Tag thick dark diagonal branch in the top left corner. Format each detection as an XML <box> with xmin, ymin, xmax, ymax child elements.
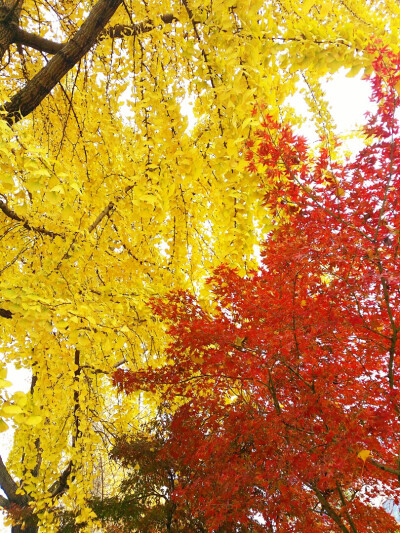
<box><xmin>2</xmin><ymin>0</ymin><xmax>122</xmax><ymax>125</ymax></box>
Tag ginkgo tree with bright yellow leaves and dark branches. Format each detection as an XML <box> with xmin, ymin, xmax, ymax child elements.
<box><xmin>0</xmin><ymin>0</ymin><xmax>400</xmax><ymax>532</ymax></box>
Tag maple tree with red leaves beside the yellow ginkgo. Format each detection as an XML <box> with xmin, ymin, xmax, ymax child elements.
<box><xmin>115</xmin><ymin>50</ymin><xmax>400</xmax><ymax>533</ymax></box>
